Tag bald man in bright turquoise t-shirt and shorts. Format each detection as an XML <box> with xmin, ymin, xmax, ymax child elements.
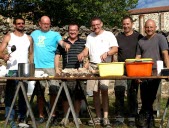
<box><xmin>31</xmin><ymin>16</ymin><xmax>70</xmax><ymax>125</ymax></box>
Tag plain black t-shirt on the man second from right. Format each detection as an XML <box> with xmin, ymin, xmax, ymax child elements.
<box><xmin>116</xmin><ymin>31</ymin><xmax>143</xmax><ymax>62</ymax></box>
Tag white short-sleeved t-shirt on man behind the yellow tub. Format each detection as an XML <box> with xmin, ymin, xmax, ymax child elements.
<box><xmin>86</xmin><ymin>30</ymin><xmax>118</xmax><ymax>63</ymax></box>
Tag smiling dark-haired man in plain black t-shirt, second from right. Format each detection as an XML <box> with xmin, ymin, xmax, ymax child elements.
<box><xmin>114</xmin><ymin>16</ymin><xmax>143</xmax><ymax>127</ymax></box>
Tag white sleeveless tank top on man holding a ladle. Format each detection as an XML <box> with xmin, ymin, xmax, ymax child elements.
<box><xmin>7</xmin><ymin>33</ymin><xmax>30</xmax><ymax>70</ymax></box>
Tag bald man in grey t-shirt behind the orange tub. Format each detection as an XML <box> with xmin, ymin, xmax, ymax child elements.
<box><xmin>136</xmin><ymin>19</ymin><xmax>169</xmax><ymax>128</ymax></box>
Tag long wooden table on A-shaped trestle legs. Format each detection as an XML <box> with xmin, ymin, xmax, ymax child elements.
<box><xmin>0</xmin><ymin>76</ymin><xmax>169</xmax><ymax>128</ymax></box>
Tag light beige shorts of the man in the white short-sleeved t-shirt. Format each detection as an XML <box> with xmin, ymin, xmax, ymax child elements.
<box><xmin>87</xmin><ymin>63</ymin><xmax>110</xmax><ymax>92</ymax></box>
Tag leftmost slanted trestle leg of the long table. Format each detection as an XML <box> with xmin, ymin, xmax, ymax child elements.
<box><xmin>4</xmin><ymin>84</ymin><xmax>21</xmax><ymax>128</ymax></box>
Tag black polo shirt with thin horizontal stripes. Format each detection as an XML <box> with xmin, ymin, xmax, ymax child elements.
<box><xmin>56</xmin><ymin>38</ymin><xmax>86</xmax><ymax>69</ymax></box>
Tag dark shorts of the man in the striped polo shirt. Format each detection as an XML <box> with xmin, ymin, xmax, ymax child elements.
<box><xmin>61</xmin><ymin>80</ymin><xmax>84</xmax><ymax>101</ymax></box>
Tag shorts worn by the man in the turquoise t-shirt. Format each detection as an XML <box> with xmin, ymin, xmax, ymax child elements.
<box><xmin>35</xmin><ymin>68</ymin><xmax>60</xmax><ymax>96</ymax></box>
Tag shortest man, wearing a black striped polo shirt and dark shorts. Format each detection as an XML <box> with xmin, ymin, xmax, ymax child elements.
<box><xmin>55</xmin><ymin>23</ymin><xmax>86</xmax><ymax>125</ymax></box>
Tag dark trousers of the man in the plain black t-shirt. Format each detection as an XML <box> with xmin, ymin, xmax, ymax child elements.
<box><xmin>114</xmin><ymin>80</ymin><xmax>138</xmax><ymax>117</ymax></box>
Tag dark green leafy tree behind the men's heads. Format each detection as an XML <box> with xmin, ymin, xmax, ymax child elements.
<box><xmin>0</xmin><ymin>0</ymin><xmax>138</xmax><ymax>26</ymax></box>
